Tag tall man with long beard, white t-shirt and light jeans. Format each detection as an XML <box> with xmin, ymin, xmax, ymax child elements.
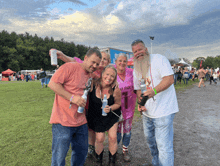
<box><xmin>131</xmin><ymin>39</ymin><xmax>179</xmax><ymax>166</ymax></box>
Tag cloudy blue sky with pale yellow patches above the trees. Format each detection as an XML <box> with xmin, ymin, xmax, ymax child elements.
<box><xmin>0</xmin><ymin>0</ymin><xmax>220</xmax><ymax>62</ymax></box>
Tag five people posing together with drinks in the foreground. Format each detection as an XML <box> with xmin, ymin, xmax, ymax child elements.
<box><xmin>48</xmin><ymin>39</ymin><xmax>179</xmax><ymax>166</ymax></box>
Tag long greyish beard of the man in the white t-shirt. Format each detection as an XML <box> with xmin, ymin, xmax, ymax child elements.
<box><xmin>134</xmin><ymin>51</ymin><xmax>150</xmax><ymax>80</ymax></box>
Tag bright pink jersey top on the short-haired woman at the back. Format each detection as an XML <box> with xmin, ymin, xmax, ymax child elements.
<box><xmin>117</xmin><ymin>68</ymin><xmax>136</xmax><ymax>119</ymax></box>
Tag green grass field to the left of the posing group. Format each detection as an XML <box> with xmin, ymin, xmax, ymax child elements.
<box><xmin>0</xmin><ymin>81</ymin><xmax>199</xmax><ymax>166</ymax></box>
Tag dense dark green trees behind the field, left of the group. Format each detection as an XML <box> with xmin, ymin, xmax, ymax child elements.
<box><xmin>0</xmin><ymin>30</ymin><xmax>90</xmax><ymax>73</ymax></box>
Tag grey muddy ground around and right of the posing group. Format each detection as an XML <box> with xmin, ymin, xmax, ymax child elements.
<box><xmin>85</xmin><ymin>82</ymin><xmax>220</xmax><ymax>166</ymax></box>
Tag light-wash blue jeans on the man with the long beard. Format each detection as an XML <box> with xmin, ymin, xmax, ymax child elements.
<box><xmin>143</xmin><ymin>114</ymin><xmax>175</xmax><ymax>166</ymax></box>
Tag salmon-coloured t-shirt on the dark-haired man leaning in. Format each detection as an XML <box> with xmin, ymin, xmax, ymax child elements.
<box><xmin>50</xmin><ymin>62</ymin><xmax>90</xmax><ymax>127</ymax></box>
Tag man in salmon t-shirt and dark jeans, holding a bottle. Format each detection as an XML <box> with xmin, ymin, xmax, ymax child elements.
<box><xmin>48</xmin><ymin>49</ymin><xmax>102</xmax><ymax>166</ymax></box>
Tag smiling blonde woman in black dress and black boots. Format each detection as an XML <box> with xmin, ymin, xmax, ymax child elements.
<box><xmin>86</xmin><ymin>65</ymin><xmax>121</xmax><ymax>165</ymax></box>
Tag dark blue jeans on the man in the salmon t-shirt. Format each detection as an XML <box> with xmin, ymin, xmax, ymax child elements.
<box><xmin>51</xmin><ymin>124</ymin><xmax>88</xmax><ymax>166</ymax></box>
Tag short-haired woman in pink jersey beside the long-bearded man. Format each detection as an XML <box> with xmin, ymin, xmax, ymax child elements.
<box><xmin>115</xmin><ymin>53</ymin><xmax>136</xmax><ymax>162</ymax></box>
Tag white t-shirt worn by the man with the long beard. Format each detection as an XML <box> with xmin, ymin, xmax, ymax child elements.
<box><xmin>133</xmin><ymin>54</ymin><xmax>179</xmax><ymax>118</ymax></box>
